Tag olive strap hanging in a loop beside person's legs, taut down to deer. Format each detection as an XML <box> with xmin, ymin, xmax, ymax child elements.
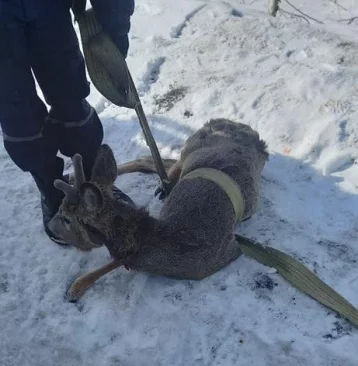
<box><xmin>72</xmin><ymin>5</ymin><xmax>172</xmax><ymax>195</ymax></box>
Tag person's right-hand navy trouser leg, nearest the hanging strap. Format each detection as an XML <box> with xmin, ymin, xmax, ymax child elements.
<box><xmin>28</xmin><ymin>0</ymin><xmax>103</xmax><ymax>178</ymax></box>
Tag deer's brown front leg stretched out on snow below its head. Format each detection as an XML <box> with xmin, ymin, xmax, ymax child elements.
<box><xmin>67</xmin><ymin>259</ymin><xmax>124</xmax><ymax>302</ymax></box>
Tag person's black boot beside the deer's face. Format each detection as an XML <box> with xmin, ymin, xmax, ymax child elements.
<box><xmin>31</xmin><ymin>157</ymin><xmax>68</xmax><ymax>245</ymax></box>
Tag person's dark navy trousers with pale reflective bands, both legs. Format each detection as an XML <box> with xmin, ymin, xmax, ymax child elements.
<box><xmin>0</xmin><ymin>0</ymin><xmax>103</xmax><ymax>179</ymax></box>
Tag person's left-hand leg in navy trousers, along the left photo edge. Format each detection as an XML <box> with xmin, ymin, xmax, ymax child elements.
<box><xmin>0</xmin><ymin>3</ymin><xmax>63</xmax><ymax>242</ymax></box>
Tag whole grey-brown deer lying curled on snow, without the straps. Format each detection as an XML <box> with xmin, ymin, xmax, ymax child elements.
<box><xmin>50</xmin><ymin>119</ymin><xmax>268</xmax><ymax>300</ymax></box>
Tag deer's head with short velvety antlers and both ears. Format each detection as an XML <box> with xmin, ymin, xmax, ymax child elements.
<box><xmin>49</xmin><ymin>145</ymin><xmax>121</xmax><ymax>250</ymax></box>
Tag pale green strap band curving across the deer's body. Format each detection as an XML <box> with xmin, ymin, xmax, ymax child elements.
<box><xmin>180</xmin><ymin>168</ymin><xmax>245</xmax><ymax>221</ymax></box>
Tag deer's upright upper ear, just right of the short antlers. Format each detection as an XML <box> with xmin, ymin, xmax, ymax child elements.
<box><xmin>91</xmin><ymin>145</ymin><xmax>117</xmax><ymax>188</ymax></box>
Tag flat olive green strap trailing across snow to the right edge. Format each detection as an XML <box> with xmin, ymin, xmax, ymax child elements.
<box><xmin>236</xmin><ymin>235</ymin><xmax>358</xmax><ymax>327</ymax></box>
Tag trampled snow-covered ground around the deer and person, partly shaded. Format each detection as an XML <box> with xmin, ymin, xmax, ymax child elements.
<box><xmin>0</xmin><ymin>0</ymin><xmax>358</xmax><ymax>366</ymax></box>
